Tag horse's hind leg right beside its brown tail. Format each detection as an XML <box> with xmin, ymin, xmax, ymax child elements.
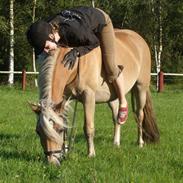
<box><xmin>132</xmin><ymin>83</ymin><xmax>148</xmax><ymax>147</ymax></box>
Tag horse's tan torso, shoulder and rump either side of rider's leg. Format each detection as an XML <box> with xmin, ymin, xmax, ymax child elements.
<box><xmin>76</xmin><ymin>30</ymin><xmax>151</xmax><ymax>100</ymax></box>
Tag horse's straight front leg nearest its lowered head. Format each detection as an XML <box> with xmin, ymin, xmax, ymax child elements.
<box><xmin>83</xmin><ymin>89</ymin><xmax>95</xmax><ymax>157</ymax></box>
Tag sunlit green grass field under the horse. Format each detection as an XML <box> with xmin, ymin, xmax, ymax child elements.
<box><xmin>0</xmin><ymin>86</ymin><xmax>183</xmax><ymax>183</ymax></box>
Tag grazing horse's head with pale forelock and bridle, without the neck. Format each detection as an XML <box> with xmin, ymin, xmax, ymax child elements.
<box><xmin>30</xmin><ymin>100</ymin><xmax>69</xmax><ymax>165</ymax></box>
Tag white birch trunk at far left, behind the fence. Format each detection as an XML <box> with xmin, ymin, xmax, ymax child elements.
<box><xmin>8</xmin><ymin>0</ymin><xmax>14</xmax><ymax>85</ymax></box>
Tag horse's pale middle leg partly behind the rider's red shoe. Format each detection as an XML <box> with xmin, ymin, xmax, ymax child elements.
<box><xmin>109</xmin><ymin>99</ymin><xmax>121</xmax><ymax>146</ymax></box>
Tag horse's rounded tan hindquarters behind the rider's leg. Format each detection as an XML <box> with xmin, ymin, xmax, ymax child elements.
<box><xmin>115</xmin><ymin>29</ymin><xmax>151</xmax><ymax>88</ymax></box>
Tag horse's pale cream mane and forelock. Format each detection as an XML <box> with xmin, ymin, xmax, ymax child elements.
<box><xmin>38</xmin><ymin>49</ymin><xmax>70</xmax><ymax>144</ymax></box>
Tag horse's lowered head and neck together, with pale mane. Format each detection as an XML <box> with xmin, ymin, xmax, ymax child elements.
<box><xmin>31</xmin><ymin>48</ymin><xmax>77</xmax><ymax>165</ymax></box>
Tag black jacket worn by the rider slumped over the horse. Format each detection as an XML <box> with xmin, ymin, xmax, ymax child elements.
<box><xmin>48</xmin><ymin>7</ymin><xmax>106</xmax><ymax>56</ymax></box>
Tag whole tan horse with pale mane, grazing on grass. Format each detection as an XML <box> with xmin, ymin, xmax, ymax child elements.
<box><xmin>30</xmin><ymin>30</ymin><xmax>159</xmax><ymax>164</ymax></box>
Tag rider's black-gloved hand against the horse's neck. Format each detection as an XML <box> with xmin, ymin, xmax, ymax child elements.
<box><xmin>62</xmin><ymin>49</ymin><xmax>79</xmax><ymax>69</ymax></box>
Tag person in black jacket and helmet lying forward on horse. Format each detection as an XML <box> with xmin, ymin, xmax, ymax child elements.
<box><xmin>27</xmin><ymin>7</ymin><xmax>128</xmax><ymax>124</ymax></box>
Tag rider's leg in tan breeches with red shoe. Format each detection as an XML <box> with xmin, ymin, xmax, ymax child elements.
<box><xmin>100</xmin><ymin>10</ymin><xmax>128</xmax><ymax>124</ymax></box>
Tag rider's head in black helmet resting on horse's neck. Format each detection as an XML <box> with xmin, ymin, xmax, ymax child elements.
<box><xmin>27</xmin><ymin>20</ymin><xmax>60</xmax><ymax>55</ymax></box>
